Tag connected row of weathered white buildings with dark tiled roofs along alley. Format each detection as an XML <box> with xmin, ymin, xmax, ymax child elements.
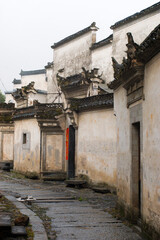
<box><xmin>3</xmin><ymin>3</ymin><xmax>160</xmax><ymax>234</ymax></box>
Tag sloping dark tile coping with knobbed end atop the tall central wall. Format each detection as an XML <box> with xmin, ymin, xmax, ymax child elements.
<box><xmin>51</xmin><ymin>22</ymin><xmax>98</xmax><ymax>49</ymax></box>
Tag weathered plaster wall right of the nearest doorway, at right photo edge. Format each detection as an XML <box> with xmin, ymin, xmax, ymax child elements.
<box><xmin>143</xmin><ymin>53</ymin><xmax>160</xmax><ymax>232</ymax></box>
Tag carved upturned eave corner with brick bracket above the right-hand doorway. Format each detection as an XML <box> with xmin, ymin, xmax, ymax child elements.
<box><xmin>108</xmin><ymin>33</ymin><xmax>144</xmax><ymax>107</ymax></box>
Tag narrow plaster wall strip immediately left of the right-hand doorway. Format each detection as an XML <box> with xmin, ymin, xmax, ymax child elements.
<box><xmin>114</xmin><ymin>87</ymin><xmax>131</xmax><ymax>204</ymax></box>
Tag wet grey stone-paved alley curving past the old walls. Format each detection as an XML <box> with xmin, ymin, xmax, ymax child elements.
<box><xmin>0</xmin><ymin>172</ymin><xmax>146</xmax><ymax>240</ymax></box>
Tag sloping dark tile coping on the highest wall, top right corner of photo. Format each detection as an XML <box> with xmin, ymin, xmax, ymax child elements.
<box><xmin>110</xmin><ymin>2</ymin><xmax>160</xmax><ymax>29</ymax></box>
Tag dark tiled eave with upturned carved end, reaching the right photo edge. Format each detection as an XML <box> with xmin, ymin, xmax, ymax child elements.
<box><xmin>108</xmin><ymin>24</ymin><xmax>160</xmax><ymax>90</ymax></box>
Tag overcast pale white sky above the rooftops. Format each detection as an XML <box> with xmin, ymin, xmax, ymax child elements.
<box><xmin>0</xmin><ymin>0</ymin><xmax>158</xmax><ymax>91</ymax></box>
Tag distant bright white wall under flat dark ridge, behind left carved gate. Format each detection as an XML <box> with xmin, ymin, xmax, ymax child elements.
<box><xmin>21</xmin><ymin>74</ymin><xmax>47</xmax><ymax>91</ymax></box>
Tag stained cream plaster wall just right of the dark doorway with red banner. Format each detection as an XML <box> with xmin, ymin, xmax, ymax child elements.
<box><xmin>76</xmin><ymin>109</ymin><xmax>117</xmax><ymax>186</ymax></box>
